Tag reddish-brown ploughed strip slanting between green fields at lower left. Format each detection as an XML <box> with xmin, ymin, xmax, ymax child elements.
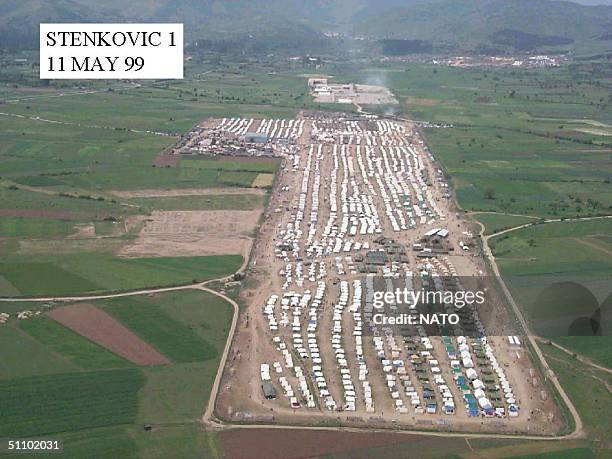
<box><xmin>47</xmin><ymin>303</ymin><xmax>170</xmax><ymax>365</ymax></box>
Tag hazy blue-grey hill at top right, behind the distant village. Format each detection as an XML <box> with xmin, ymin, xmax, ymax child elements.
<box><xmin>353</xmin><ymin>0</ymin><xmax>612</xmax><ymax>53</ymax></box>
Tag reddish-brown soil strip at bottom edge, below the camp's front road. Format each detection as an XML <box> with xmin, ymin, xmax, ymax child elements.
<box><xmin>218</xmin><ymin>428</ymin><xmax>421</xmax><ymax>459</ymax></box>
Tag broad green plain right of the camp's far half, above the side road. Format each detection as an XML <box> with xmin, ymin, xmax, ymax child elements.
<box><xmin>372</xmin><ymin>63</ymin><xmax>612</xmax><ymax>216</ymax></box>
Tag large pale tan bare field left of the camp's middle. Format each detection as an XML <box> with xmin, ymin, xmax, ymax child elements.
<box><xmin>119</xmin><ymin>210</ymin><xmax>262</xmax><ymax>258</ymax></box>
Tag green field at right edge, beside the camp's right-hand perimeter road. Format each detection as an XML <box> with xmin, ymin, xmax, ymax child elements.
<box><xmin>490</xmin><ymin>219</ymin><xmax>612</xmax><ymax>367</ymax></box>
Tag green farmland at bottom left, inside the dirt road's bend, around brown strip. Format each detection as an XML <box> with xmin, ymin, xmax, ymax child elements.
<box><xmin>0</xmin><ymin>290</ymin><xmax>232</xmax><ymax>459</ymax></box>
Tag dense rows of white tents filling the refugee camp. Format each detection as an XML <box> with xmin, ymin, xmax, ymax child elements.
<box><xmin>256</xmin><ymin>117</ymin><xmax>518</xmax><ymax>416</ymax></box>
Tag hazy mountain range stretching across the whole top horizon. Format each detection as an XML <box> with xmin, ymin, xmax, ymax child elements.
<box><xmin>0</xmin><ymin>0</ymin><xmax>612</xmax><ymax>53</ymax></box>
